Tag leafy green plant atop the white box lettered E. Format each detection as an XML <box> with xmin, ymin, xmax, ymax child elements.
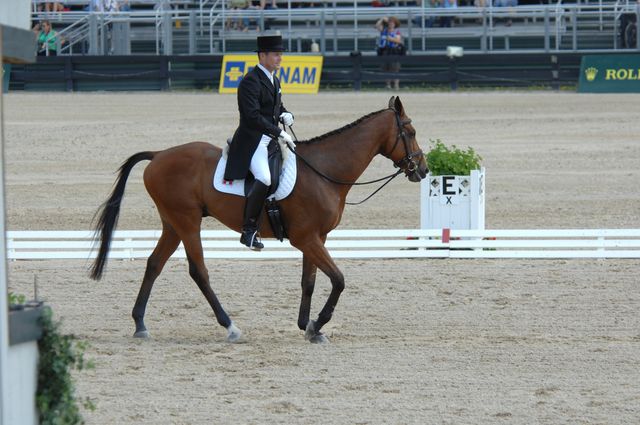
<box><xmin>425</xmin><ymin>139</ymin><xmax>482</xmax><ymax>176</ymax></box>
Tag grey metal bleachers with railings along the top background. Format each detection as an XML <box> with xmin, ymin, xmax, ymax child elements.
<box><xmin>32</xmin><ymin>0</ymin><xmax>640</xmax><ymax>55</ymax></box>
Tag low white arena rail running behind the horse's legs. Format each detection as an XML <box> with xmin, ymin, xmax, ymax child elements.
<box><xmin>7</xmin><ymin>229</ymin><xmax>640</xmax><ymax>260</ymax></box>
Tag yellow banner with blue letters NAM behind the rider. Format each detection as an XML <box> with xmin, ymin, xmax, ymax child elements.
<box><xmin>219</xmin><ymin>53</ymin><xmax>322</xmax><ymax>94</ymax></box>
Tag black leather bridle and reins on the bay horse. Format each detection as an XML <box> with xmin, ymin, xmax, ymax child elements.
<box><xmin>283</xmin><ymin>107</ymin><xmax>423</xmax><ymax>205</ymax></box>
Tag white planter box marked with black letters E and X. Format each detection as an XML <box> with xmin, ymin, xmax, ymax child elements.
<box><xmin>420</xmin><ymin>167</ymin><xmax>485</xmax><ymax>230</ymax></box>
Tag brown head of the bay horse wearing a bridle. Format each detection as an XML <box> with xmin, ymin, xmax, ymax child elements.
<box><xmin>382</xmin><ymin>96</ymin><xmax>429</xmax><ymax>182</ymax></box>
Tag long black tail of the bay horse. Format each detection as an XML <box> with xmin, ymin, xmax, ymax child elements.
<box><xmin>90</xmin><ymin>152</ymin><xmax>156</xmax><ymax>280</ymax></box>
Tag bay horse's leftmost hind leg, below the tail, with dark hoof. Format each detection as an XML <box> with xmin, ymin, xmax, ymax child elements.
<box><xmin>131</xmin><ymin>222</ymin><xmax>180</xmax><ymax>338</ymax></box>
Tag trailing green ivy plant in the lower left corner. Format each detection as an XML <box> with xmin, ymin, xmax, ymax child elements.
<box><xmin>36</xmin><ymin>309</ymin><xmax>95</xmax><ymax>425</ymax></box>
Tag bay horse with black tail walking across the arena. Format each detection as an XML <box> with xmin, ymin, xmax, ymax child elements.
<box><xmin>90</xmin><ymin>97</ymin><xmax>427</xmax><ymax>343</ymax></box>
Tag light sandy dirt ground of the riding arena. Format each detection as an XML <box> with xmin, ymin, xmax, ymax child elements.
<box><xmin>4</xmin><ymin>92</ymin><xmax>640</xmax><ymax>424</ymax></box>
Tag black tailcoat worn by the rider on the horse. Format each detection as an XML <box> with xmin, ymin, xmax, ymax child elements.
<box><xmin>224</xmin><ymin>65</ymin><xmax>287</xmax><ymax>180</ymax></box>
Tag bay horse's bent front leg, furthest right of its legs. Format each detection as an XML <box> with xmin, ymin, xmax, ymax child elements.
<box><xmin>303</xmin><ymin>243</ymin><xmax>344</xmax><ymax>343</ymax></box>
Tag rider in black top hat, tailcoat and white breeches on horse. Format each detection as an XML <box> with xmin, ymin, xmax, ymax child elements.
<box><xmin>224</xmin><ymin>35</ymin><xmax>295</xmax><ymax>251</ymax></box>
